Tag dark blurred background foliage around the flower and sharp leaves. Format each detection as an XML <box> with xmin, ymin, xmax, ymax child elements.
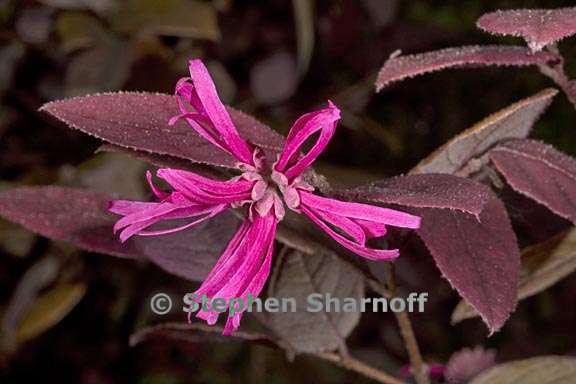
<box><xmin>0</xmin><ymin>0</ymin><xmax>576</xmax><ymax>384</ymax></box>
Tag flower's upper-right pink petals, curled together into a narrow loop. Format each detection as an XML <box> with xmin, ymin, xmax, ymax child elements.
<box><xmin>274</xmin><ymin>101</ymin><xmax>340</xmax><ymax>182</ymax></box>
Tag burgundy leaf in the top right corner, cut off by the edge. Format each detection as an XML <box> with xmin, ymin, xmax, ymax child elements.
<box><xmin>477</xmin><ymin>7</ymin><xmax>576</xmax><ymax>51</ymax></box>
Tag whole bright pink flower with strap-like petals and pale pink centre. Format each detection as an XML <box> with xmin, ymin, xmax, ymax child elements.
<box><xmin>110</xmin><ymin>60</ymin><xmax>420</xmax><ymax>334</ymax></box>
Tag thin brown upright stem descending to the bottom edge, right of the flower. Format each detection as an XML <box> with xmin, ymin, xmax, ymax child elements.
<box><xmin>377</xmin><ymin>263</ymin><xmax>430</xmax><ymax>384</ymax></box>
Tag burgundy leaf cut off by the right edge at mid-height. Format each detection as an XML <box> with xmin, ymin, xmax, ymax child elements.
<box><xmin>490</xmin><ymin>139</ymin><xmax>576</xmax><ymax>223</ymax></box>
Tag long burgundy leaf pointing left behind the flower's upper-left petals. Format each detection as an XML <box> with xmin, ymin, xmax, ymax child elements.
<box><xmin>41</xmin><ymin>92</ymin><xmax>284</xmax><ymax>167</ymax></box>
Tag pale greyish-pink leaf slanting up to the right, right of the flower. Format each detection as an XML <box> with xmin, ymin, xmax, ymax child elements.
<box><xmin>410</xmin><ymin>88</ymin><xmax>558</xmax><ymax>176</ymax></box>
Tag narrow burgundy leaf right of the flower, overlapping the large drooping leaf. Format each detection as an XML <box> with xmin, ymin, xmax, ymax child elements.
<box><xmin>336</xmin><ymin>174</ymin><xmax>491</xmax><ymax>215</ymax></box>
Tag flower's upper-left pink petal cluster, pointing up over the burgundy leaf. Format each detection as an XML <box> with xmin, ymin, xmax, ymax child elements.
<box><xmin>169</xmin><ymin>59</ymin><xmax>254</xmax><ymax>165</ymax></box>
